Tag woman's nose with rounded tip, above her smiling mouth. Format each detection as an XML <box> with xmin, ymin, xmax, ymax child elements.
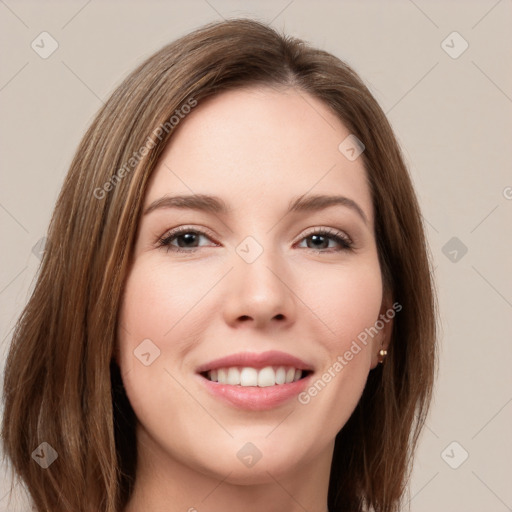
<box><xmin>223</xmin><ymin>250</ymin><xmax>297</xmax><ymax>328</ymax></box>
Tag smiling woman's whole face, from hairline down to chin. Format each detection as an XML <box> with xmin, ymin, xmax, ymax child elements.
<box><xmin>116</xmin><ymin>88</ymin><xmax>392</xmax><ymax>483</ymax></box>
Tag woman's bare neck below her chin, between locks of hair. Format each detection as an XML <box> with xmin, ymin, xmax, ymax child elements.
<box><xmin>124</xmin><ymin>425</ymin><xmax>334</xmax><ymax>512</ymax></box>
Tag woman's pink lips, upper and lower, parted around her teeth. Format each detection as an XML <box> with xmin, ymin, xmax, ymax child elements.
<box><xmin>197</xmin><ymin>350</ymin><xmax>313</xmax><ymax>411</ymax></box>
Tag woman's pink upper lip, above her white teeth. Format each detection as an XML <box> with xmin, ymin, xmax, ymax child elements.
<box><xmin>196</xmin><ymin>350</ymin><xmax>313</xmax><ymax>373</ymax></box>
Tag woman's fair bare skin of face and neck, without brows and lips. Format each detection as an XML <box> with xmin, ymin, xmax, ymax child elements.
<box><xmin>116</xmin><ymin>87</ymin><xmax>392</xmax><ymax>512</ymax></box>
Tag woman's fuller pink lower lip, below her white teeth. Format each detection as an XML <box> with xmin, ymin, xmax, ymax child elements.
<box><xmin>199</xmin><ymin>374</ymin><xmax>312</xmax><ymax>411</ymax></box>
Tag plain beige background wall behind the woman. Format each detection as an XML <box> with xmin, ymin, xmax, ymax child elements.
<box><xmin>0</xmin><ymin>0</ymin><xmax>512</xmax><ymax>512</ymax></box>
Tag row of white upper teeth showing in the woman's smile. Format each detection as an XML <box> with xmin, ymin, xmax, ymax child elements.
<box><xmin>207</xmin><ymin>366</ymin><xmax>302</xmax><ymax>388</ymax></box>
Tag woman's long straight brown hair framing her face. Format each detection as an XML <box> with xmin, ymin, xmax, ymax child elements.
<box><xmin>2</xmin><ymin>19</ymin><xmax>437</xmax><ymax>512</ymax></box>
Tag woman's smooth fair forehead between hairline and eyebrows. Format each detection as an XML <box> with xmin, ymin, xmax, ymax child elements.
<box><xmin>145</xmin><ymin>87</ymin><xmax>372</xmax><ymax>221</ymax></box>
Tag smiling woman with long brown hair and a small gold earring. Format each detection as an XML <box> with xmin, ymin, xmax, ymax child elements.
<box><xmin>3</xmin><ymin>19</ymin><xmax>436</xmax><ymax>512</ymax></box>
